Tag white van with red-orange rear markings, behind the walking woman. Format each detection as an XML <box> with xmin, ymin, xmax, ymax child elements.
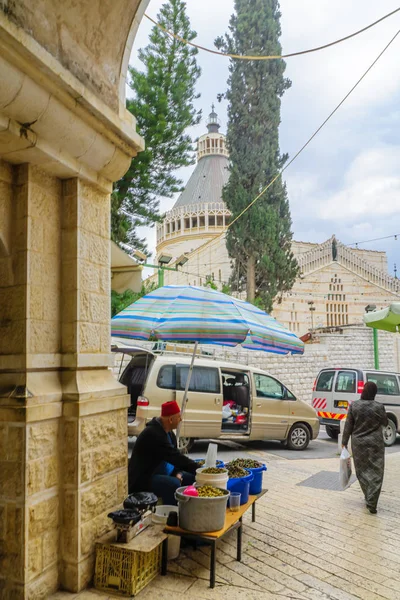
<box><xmin>311</xmin><ymin>368</ymin><xmax>400</xmax><ymax>446</ymax></box>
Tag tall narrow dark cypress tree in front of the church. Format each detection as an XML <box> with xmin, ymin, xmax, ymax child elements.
<box><xmin>215</xmin><ymin>0</ymin><xmax>297</xmax><ymax>310</ymax></box>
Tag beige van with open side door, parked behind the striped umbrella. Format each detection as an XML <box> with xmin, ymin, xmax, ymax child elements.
<box><xmin>114</xmin><ymin>348</ymin><xmax>319</xmax><ymax>450</ymax></box>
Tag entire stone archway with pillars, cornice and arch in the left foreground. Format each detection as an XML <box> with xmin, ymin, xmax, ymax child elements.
<box><xmin>0</xmin><ymin>0</ymin><xmax>149</xmax><ymax>599</ymax></box>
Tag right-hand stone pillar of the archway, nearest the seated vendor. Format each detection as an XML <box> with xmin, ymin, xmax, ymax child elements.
<box><xmin>60</xmin><ymin>178</ymin><xmax>129</xmax><ymax>591</ymax></box>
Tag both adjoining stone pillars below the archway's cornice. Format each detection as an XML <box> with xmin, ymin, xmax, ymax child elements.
<box><xmin>0</xmin><ymin>163</ymin><xmax>128</xmax><ymax>600</ymax></box>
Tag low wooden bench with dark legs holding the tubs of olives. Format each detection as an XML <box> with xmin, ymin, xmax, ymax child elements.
<box><xmin>164</xmin><ymin>490</ymin><xmax>268</xmax><ymax>588</ymax></box>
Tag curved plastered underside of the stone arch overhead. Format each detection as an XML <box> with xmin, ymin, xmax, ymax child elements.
<box><xmin>0</xmin><ymin>0</ymin><xmax>150</xmax><ymax>112</ymax></box>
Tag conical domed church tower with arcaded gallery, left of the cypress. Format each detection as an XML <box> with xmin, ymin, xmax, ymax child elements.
<box><xmin>156</xmin><ymin>106</ymin><xmax>231</xmax><ymax>285</ymax></box>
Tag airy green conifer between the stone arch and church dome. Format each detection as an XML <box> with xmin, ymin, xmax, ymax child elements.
<box><xmin>111</xmin><ymin>0</ymin><xmax>201</xmax><ymax>249</ymax></box>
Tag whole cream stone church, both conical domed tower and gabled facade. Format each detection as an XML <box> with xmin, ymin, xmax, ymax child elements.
<box><xmin>152</xmin><ymin>107</ymin><xmax>400</xmax><ymax>335</ymax></box>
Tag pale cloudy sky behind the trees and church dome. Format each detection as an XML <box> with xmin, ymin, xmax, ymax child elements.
<box><xmin>128</xmin><ymin>0</ymin><xmax>400</xmax><ymax>276</ymax></box>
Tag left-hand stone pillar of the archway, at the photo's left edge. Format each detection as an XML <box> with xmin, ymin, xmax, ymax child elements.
<box><xmin>0</xmin><ymin>163</ymin><xmax>62</xmax><ymax>598</ymax></box>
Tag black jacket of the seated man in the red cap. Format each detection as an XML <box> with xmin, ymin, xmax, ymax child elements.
<box><xmin>128</xmin><ymin>417</ymin><xmax>199</xmax><ymax>494</ymax></box>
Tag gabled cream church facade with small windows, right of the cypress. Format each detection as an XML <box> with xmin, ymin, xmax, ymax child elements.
<box><xmin>273</xmin><ymin>236</ymin><xmax>400</xmax><ymax>335</ymax></box>
